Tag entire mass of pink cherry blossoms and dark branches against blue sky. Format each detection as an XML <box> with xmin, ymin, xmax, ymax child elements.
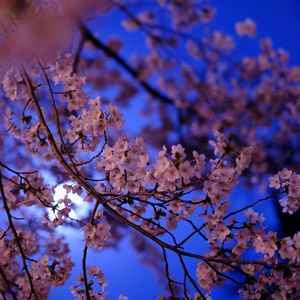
<box><xmin>0</xmin><ymin>0</ymin><xmax>300</xmax><ymax>300</ymax></box>
